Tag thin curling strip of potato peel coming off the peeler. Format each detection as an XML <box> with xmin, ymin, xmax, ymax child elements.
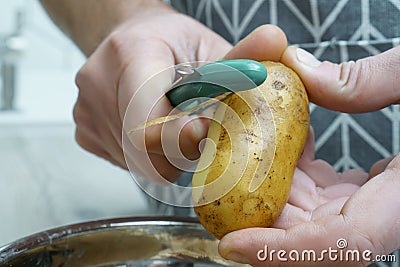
<box><xmin>128</xmin><ymin>92</ymin><xmax>232</xmax><ymax>134</ymax></box>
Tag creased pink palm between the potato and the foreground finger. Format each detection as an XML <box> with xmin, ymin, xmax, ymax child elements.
<box><xmin>274</xmin><ymin>129</ymin><xmax>368</xmax><ymax>229</ymax></box>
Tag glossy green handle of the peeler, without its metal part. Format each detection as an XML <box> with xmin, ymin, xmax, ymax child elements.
<box><xmin>166</xmin><ymin>59</ymin><xmax>267</xmax><ymax>107</ymax></box>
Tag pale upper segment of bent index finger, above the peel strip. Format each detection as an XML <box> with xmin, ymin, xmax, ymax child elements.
<box><xmin>118</xmin><ymin>42</ymin><xmax>175</xmax><ymax>129</ymax></box>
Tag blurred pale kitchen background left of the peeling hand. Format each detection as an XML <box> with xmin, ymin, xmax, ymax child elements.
<box><xmin>0</xmin><ymin>0</ymin><xmax>148</xmax><ymax>246</ymax></box>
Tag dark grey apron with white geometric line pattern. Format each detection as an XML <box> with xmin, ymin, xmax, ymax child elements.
<box><xmin>171</xmin><ymin>0</ymin><xmax>400</xmax><ymax>171</ymax></box>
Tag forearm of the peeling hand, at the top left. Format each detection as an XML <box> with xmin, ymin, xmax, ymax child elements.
<box><xmin>41</xmin><ymin>0</ymin><xmax>177</xmax><ymax>56</ymax></box>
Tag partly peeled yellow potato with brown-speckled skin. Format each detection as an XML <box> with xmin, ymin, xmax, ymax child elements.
<box><xmin>193</xmin><ymin>62</ymin><xmax>309</xmax><ymax>239</ymax></box>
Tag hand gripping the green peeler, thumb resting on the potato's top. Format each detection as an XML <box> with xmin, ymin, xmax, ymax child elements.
<box><xmin>74</xmin><ymin>3</ymin><xmax>286</xmax><ymax>183</ymax></box>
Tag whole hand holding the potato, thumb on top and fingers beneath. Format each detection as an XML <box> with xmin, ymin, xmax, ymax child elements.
<box><xmin>219</xmin><ymin>40</ymin><xmax>400</xmax><ymax>266</ymax></box>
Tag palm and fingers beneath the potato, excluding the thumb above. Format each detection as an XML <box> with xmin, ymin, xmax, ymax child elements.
<box><xmin>219</xmin><ymin>129</ymin><xmax>400</xmax><ymax>266</ymax></box>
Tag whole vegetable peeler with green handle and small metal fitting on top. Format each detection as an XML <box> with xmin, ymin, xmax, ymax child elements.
<box><xmin>166</xmin><ymin>59</ymin><xmax>267</xmax><ymax>110</ymax></box>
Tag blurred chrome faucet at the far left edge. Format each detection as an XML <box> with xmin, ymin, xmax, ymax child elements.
<box><xmin>0</xmin><ymin>9</ymin><xmax>25</xmax><ymax>110</ymax></box>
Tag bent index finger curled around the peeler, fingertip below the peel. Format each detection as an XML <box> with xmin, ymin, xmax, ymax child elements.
<box><xmin>119</xmin><ymin>41</ymin><xmax>225</xmax><ymax>165</ymax></box>
